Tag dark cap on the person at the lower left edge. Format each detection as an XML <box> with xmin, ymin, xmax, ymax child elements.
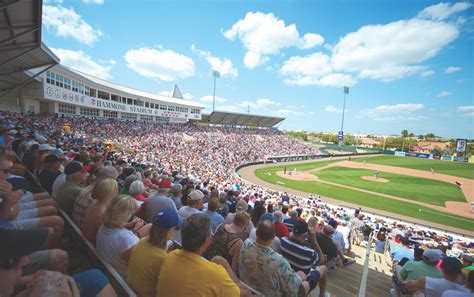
<box><xmin>0</xmin><ymin>228</ymin><xmax>49</xmax><ymax>267</ymax></box>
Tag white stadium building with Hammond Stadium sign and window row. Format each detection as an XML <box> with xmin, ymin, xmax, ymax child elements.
<box><xmin>10</xmin><ymin>65</ymin><xmax>203</xmax><ymax>123</ymax></box>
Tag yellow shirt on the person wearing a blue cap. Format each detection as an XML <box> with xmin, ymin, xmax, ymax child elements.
<box><xmin>127</xmin><ymin>237</ymin><xmax>167</xmax><ymax>297</ymax></box>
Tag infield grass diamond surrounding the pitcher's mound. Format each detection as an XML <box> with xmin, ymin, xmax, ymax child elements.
<box><xmin>313</xmin><ymin>167</ymin><xmax>466</xmax><ymax>206</ymax></box>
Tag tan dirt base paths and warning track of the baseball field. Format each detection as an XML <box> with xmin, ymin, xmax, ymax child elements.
<box><xmin>239</xmin><ymin>159</ymin><xmax>474</xmax><ymax>237</ymax></box>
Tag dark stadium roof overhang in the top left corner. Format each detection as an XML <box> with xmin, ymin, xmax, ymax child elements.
<box><xmin>0</xmin><ymin>0</ymin><xmax>59</xmax><ymax>95</ymax></box>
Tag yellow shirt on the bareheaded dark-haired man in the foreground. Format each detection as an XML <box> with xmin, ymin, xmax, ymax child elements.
<box><xmin>156</xmin><ymin>250</ymin><xmax>240</xmax><ymax>297</ymax></box>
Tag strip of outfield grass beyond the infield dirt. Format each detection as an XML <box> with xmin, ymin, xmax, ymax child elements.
<box><xmin>353</xmin><ymin>155</ymin><xmax>474</xmax><ymax>179</ymax></box>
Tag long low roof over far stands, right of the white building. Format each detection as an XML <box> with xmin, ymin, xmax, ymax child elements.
<box><xmin>201</xmin><ymin>111</ymin><xmax>285</xmax><ymax>127</ymax></box>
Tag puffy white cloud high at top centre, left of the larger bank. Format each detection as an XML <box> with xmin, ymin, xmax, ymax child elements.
<box><xmin>223</xmin><ymin>12</ymin><xmax>324</xmax><ymax>69</ymax></box>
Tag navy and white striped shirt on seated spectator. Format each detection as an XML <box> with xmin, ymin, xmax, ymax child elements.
<box><xmin>280</xmin><ymin>237</ymin><xmax>319</xmax><ymax>275</ymax></box>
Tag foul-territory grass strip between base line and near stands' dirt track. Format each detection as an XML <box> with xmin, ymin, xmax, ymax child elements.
<box><xmin>255</xmin><ymin>165</ymin><xmax>474</xmax><ymax>231</ymax></box>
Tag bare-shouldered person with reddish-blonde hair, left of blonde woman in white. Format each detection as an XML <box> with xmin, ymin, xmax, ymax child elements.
<box><xmin>82</xmin><ymin>178</ymin><xmax>118</xmax><ymax>245</ymax></box>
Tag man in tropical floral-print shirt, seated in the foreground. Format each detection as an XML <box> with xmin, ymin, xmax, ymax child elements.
<box><xmin>239</xmin><ymin>219</ymin><xmax>316</xmax><ymax>296</ymax></box>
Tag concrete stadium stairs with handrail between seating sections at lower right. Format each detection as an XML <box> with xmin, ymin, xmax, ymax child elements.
<box><xmin>324</xmin><ymin>246</ymin><xmax>392</xmax><ymax>297</ymax></box>
